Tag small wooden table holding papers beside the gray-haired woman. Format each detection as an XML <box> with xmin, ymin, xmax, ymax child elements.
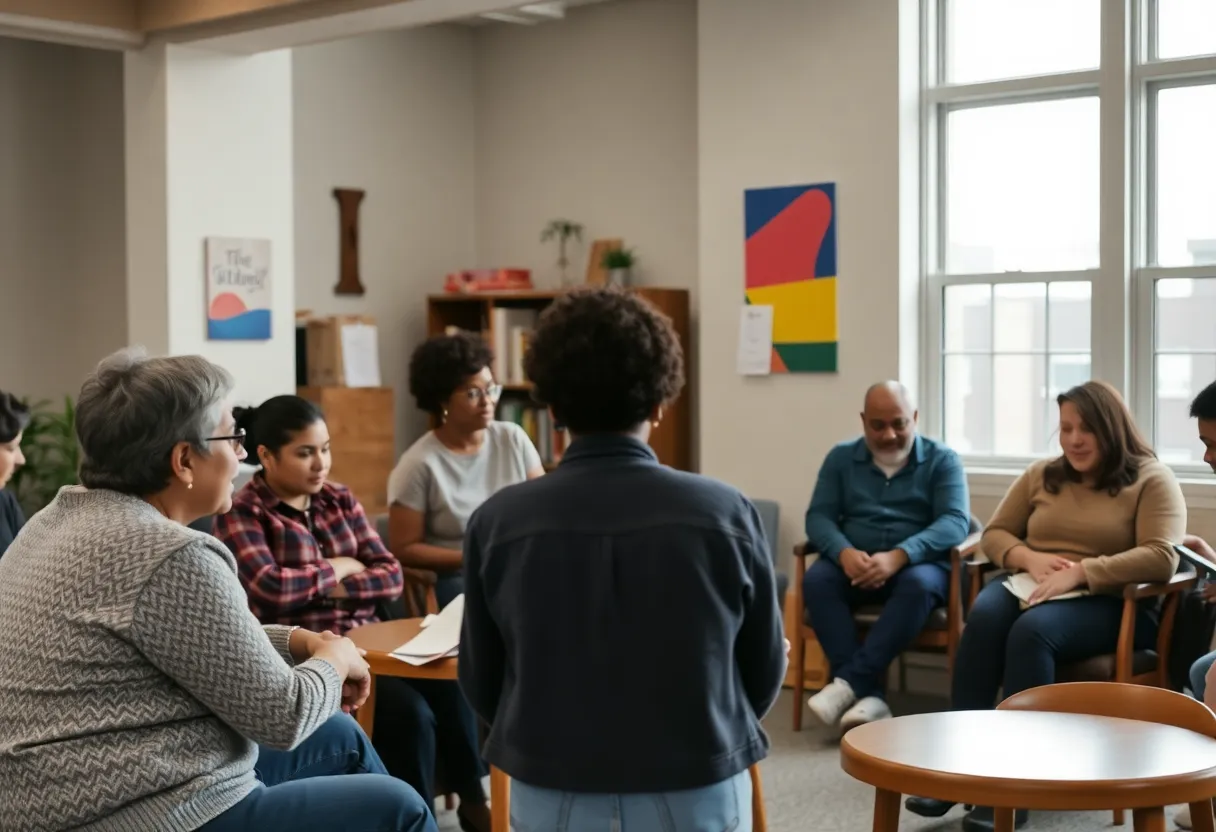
<box><xmin>347</xmin><ymin>618</ymin><xmax>511</xmax><ymax>832</ymax></box>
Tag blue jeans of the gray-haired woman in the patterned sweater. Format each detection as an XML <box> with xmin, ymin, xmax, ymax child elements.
<box><xmin>201</xmin><ymin>714</ymin><xmax>438</xmax><ymax>832</ymax></box>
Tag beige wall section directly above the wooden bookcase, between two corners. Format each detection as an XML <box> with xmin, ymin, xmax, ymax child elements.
<box><xmin>475</xmin><ymin>0</ymin><xmax>698</xmax><ymax>293</ymax></box>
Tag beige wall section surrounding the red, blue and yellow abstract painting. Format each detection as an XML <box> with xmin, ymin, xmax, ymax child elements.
<box><xmin>698</xmin><ymin>0</ymin><xmax>916</xmax><ymax>559</ymax></box>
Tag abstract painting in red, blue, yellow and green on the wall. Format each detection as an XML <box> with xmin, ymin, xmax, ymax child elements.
<box><xmin>743</xmin><ymin>182</ymin><xmax>837</xmax><ymax>372</ymax></box>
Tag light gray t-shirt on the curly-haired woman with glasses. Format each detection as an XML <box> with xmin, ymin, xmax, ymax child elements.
<box><xmin>388</xmin><ymin>422</ymin><xmax>541</xmax><ymax>550</ymax></box>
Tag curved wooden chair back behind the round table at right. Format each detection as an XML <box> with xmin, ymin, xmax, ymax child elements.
<box><xmin>997</xmin><ymin>682</ymin><xmax>1216</xmax><ymax>738</ymax></box>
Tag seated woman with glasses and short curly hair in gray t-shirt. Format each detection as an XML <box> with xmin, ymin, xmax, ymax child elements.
<box><xmin>388</xmin><ymin>332</ymin><xmax>545</xmax><ymax>607</ymax></box>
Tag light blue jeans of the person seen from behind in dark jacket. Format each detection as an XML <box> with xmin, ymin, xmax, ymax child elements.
<box><xmin>511</xmin><ymin>770</ymin><xmax>751</xmax><ymax>832</ymax></box>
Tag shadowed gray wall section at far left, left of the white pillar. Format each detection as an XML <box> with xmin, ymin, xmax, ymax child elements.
<box><xmin>0</xmin><ymin>38</ymin><xmax>126</xmax><ymax>398</ymax></box>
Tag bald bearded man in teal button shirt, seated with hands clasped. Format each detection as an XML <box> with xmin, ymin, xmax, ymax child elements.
<box><xmin>803</xmin><ymin>382</ymin><xmax>970</xmax><ymax>731</ymax></box>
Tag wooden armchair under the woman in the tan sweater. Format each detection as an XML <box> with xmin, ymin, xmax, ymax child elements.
<box><xmin>967</xmin><ymin>544</ymin><xmax>1198</xmax><ymax>687</ymax></box>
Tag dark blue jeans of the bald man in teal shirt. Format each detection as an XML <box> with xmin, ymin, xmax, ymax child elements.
<box><xmin>803</xmin><ymin>557</ymin><xmax>950</xmax><ymax>699</ymax></box>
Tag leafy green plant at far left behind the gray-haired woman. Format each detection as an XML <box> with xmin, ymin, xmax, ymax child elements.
<box><xmin>10</xmin><ymin>397</ymin><xmax>80</xmax><ymax>517</ymax></box>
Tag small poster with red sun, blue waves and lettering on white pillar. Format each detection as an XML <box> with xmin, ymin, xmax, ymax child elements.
<box><xmin>206</xmin><ymin>237</ymin><xmax>271</xmax><ymax>341</ymax></box>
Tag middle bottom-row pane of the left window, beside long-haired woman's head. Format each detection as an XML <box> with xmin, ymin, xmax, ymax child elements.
<box><xmin>992</xmin><ymin>355</ymin><xmax>1047</xmax><ymax>456</ymax></box>
